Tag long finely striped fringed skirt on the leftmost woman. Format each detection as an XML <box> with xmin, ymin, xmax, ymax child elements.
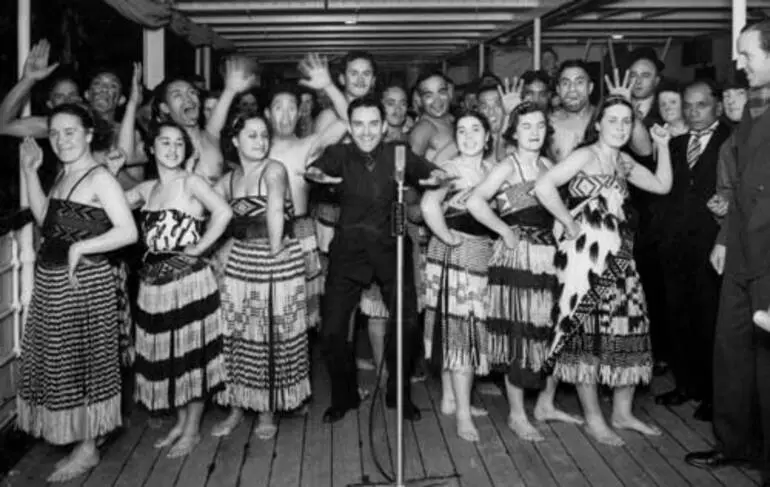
<box><xmin>17</xmin><ymin>259</ymin><xmax>121</xmax><ymax>445</ymax></box>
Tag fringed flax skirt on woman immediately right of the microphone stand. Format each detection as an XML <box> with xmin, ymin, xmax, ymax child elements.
<box><xmin>425</xmin><ymin>232</ymin><xmax>492</xmax><ymax>375</ymax></box>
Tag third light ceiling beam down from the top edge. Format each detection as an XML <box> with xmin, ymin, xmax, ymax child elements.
<box><xmin>214</xmin><ymin>23</ymin><xmax>497</xmax><ymax>34</ymax></box>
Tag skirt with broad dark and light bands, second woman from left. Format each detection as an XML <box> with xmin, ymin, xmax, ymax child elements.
<box><xmin>134</xmin><ymin>254</ymin><xmax>225</xmax><ymax>411</ymax></box>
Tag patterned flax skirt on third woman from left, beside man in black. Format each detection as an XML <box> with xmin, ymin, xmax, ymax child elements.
<box><xmin>216</xmin><ymin>239</ymin><xmax>311</xmax><ymax>411</ymax></box>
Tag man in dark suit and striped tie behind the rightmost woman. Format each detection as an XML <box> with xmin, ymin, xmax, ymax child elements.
<box><xmin>656</xmin><ymin>80</ymin><xmax>730</xmax><ymax>421</ymax></box>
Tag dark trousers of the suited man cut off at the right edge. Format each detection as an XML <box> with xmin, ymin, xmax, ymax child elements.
<box><xmin>713</xmin><ymin>274</ymin><xmax>770</xmax><ymax>481</ymax></box>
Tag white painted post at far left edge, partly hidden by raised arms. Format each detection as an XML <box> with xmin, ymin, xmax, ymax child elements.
<box><xmin>13</xmin><ymin>0</ymin><xmax>35</xmax><ymax>355</ymax></box>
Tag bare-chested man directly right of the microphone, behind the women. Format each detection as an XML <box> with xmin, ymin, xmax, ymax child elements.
<box><xmin>409</xmin><ymin>73</ymin><xmax>458</xmax><ymax>164</ymax></box>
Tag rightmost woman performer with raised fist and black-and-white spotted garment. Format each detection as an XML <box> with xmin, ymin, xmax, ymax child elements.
<box><xmin>535</xmin><ymin>95</ymin><xmax>671</xmax><ymax>446</ymax></box>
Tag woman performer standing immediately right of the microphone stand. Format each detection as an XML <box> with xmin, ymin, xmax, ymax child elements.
<box><xmin>421</xmin><ymin>112</ymin><xmax>494</xmax><ymax>441</ymax></box>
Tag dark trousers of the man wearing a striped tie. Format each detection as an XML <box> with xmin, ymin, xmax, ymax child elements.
<box><xmin>660</xmin><ymin>237</ymin><xmax>721</xmax><ymax>401</ymax></box>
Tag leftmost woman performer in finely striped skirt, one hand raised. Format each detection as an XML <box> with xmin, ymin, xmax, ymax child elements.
<box><xmin>17</xmin><ymin>104</ymin><xmax>137</xmax><ymax>482</ymax></box>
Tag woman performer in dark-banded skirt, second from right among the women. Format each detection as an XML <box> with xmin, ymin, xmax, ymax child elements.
<box><xmin>467</xmin><ymin>102</ymin><xmax>582</xmax><ymax>441</ymax></box>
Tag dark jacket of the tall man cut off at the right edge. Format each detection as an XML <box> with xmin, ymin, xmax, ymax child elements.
<box><xmin>723</xmin><ymin>107</ymin><xmax>770</xmax><ymax>280</ymax></box>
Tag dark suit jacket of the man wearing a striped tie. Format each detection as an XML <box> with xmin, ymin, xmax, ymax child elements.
<box><xmin>655</xmin><ymin>122</ymin><xmax>731</xmax><ymax>256</ymax></box>
